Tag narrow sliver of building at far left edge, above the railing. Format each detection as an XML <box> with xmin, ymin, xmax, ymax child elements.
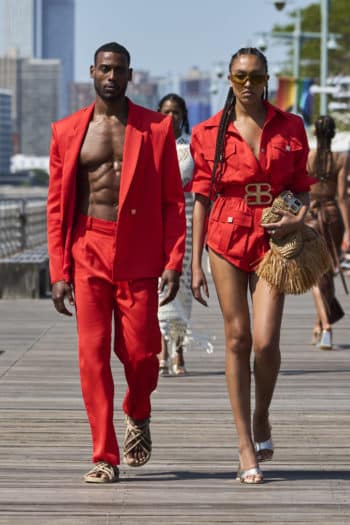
<box><xmin>0</xmin><ymin>89</ymin><xmax>12</xmax><ymax>176</ymax></box>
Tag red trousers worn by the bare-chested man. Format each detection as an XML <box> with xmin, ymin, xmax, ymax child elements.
<box><xmin>72</xmin><ymin>215</ymin><xmax>161</xmax><ymax>465</ymax></box>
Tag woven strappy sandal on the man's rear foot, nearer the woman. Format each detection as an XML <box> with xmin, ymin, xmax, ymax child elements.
<box><xmin>124</xmin><ymin>416</ymin><xmax>152</xmax><ymax>467</ymax></box>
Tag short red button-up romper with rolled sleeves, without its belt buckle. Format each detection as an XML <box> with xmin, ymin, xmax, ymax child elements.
<box><xmin>191</xmin><ymin>102</ymin><xmax>315</xmax><ymax>272</ymax></box>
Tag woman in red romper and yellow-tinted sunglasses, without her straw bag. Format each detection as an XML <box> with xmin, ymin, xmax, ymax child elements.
<box><xmin>191</xmin><ymin>48</ymin><xmax>313</xmax><ymax>483</ymax></box>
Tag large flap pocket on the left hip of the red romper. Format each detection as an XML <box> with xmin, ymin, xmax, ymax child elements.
<box><xmin>208</xmin><ymin>207</ymin><xmax>253</xmax><ymax>259</ymax></box>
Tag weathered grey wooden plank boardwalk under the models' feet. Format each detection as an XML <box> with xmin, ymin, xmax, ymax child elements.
<box><xmin>0</xmin><ymin>268</ymin><xmax>350</xmax><ymax>525</ymax></box>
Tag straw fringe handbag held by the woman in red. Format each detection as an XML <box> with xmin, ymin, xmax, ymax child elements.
<box><xmin>256</xmin><ymin>191</ymin><xmax>331</xmax><ymax>294</ymax></box>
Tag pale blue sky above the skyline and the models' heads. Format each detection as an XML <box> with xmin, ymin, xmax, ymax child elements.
<box><xmin>75</xmin><ymin>0</ymin><xmax>315</xmax><ymax>87</ymax></box>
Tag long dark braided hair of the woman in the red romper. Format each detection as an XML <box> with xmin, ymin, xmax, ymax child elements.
<box><xmin>209</xmin><ymin>47</ymin><xmax>268</xmax><ymax>200</ymax></box>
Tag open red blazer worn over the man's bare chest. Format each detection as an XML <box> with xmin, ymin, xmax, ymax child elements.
<box><xmin>47</xmin><ymin>100</ymin><xmax>186</xmax><ymax>283</ymax></box>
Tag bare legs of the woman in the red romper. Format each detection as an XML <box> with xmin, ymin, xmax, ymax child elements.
<box><xmin>209</xmin><ymin>251</ymin><xmax>283</xmax><ymax>476</ymax></box>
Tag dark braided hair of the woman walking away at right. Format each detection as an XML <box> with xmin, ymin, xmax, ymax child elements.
<box><xmin>315</xmin><ymin>115</ymin><xmax>335</xmax><ymax>181</ymax></box>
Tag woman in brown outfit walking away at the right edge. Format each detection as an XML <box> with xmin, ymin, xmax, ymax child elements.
<box><xmin>306</xmin><ymin>115</ymin><xmax>350</xmax><ymax>350</ymax></box>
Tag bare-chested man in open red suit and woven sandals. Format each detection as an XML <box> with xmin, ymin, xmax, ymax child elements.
<box><xmin>47</xmin><ymin>42</ymin><xmax>185</xmax><ymax>483</ymax></box>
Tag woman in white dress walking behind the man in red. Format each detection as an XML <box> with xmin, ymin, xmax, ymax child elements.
<box><xmin>158</xmin><ymin>93</ymin><xmax>193</xmax><ymax>375</ymax></box>
